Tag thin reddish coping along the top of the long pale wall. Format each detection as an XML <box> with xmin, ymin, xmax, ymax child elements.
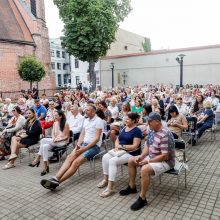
<box><xmin>101</xmin><ymin>44</ymin><xmax>220</xmax><ymax>60</ymax></box>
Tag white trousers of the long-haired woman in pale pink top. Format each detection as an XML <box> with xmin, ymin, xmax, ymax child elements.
<box><xmin>38</xmin><ymin>138</ymin><xmax>66</xmax><ymax>161</ymax></box>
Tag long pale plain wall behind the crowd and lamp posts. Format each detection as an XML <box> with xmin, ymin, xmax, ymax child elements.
<box><xmin>100</xmin><ymin>45</ymin><xmax>220</xmax><ymax>87</ymax></box>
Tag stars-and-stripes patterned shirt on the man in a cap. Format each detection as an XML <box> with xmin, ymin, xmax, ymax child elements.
<box><xmin>146</xmin><ymin>127</ymin><xmax>175</xmax><ymax>168</ymax></box>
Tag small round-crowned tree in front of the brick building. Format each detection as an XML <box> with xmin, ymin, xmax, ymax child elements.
<box><xmin>18</xmin><ymin>56</ymin><xmax>46</xmax><ymax>89</ymax></box>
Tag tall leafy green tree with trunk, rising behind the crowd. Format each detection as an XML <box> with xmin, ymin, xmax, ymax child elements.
<box><xmin>54</xmin><ymin>0</ymin><xmax>131</xmax><ymax>89</ymax></box>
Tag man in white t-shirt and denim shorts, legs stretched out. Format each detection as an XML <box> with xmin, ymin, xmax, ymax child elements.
<box><xmin>41</xmin><ymin>105</ymin><xmax>104</xmax><ymax>190</ymax></box>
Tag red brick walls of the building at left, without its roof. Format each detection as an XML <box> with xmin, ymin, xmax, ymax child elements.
<box><xmin>0</xmin><ymin>0</ymin><xmax>56</xmax><ymax>91</ymax></box>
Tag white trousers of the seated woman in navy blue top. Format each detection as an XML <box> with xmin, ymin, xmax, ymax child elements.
<box><xmin>102</xmin><ymin>153</ymin><xmax>133</xmax><ymax>182</ymax></box>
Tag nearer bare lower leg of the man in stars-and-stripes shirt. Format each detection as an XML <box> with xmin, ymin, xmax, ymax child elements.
<box><xmin>140</xmin><ymin>165</ymin><xmax>154</xmax><ymax>200</ymax></box>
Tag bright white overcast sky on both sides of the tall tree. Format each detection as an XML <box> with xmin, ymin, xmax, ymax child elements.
<box><xmin>45</xmin><ymin>0</ymin><xmax>220</xmax><ymax>50</ymax></box>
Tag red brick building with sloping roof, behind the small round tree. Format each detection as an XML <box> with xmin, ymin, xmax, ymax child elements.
<box><xmin>0</xmin><ymin>0</ymin><xmax>55</xmax><ymax>91</ymax></box>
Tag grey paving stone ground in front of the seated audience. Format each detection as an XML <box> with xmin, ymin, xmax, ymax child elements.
<box><xmin>0</xmin><ymin>131</ymin><xmax>220</xmax><ymax>220</ymax></box>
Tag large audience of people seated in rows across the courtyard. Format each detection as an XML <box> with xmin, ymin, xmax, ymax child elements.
<box><xmin>0</xmin><ymin>84</ymin><xmax>220</xmax><ymax>210</ymax></box>
